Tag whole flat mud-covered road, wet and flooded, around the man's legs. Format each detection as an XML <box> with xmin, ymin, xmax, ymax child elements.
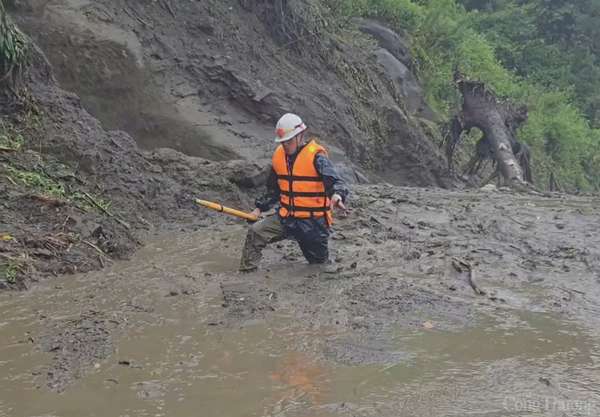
<box><xmin>0</xmin><ymin>185</ymin><xmax>600</xmax><ymax>417</ymax></box>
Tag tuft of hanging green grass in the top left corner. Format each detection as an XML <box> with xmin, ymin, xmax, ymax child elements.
<box><xmin>0</xmin><ymin>0</ymin><xmax>28</xmax><ymax>86</ymax></box>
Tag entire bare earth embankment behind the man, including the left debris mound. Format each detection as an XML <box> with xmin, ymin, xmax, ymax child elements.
<box><xmin>0</xmin><ymin>0</ymin><xmax>448</xmax><ymax>287</ymax></box>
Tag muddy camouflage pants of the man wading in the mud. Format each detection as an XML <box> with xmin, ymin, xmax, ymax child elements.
<box><xmin>240</xmin><ymin>215</ymin><xmax>329</xmax><ymax>271</ymax></box>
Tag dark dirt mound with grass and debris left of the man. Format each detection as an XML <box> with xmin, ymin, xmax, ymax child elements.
<box><xmin>0</xmin><ymin>48</ymin><xmax>262</xmax><ymax>287</ymax></box>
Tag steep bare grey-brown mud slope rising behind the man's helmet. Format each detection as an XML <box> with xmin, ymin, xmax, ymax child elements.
<box><xmin>9</xmin><ymin>0</ymin><xmax>453</xmax><ymax>185</ymax></box>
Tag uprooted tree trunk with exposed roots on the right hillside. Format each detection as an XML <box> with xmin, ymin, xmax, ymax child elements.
<box><xmin>444</xmin><ymin>72</ymin><xmax>533</xmax><ymax>187</ymax></box>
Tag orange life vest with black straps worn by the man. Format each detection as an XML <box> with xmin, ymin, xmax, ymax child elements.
<box><xmin>273</xmin><ymin>139</ymin><xmax>333</xmax><ymax>225</ymax></box>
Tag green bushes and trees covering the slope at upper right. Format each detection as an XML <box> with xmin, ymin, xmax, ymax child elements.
<box><xmin>329</xmin><ymin>0</ymin><xmax>600</xmax><ymax>190</ymax></box>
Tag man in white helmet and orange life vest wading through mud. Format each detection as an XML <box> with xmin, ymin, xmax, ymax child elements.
<box><xmin>240</xmin><ymin>113</ymin><xmax>349</xmax><ymax>272</ymax></box>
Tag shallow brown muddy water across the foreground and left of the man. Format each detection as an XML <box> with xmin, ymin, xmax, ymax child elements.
<box><xmin>0</xmin><ymin>226</ymin><xmax>600</xmax><ymax>417</ymax></box>
